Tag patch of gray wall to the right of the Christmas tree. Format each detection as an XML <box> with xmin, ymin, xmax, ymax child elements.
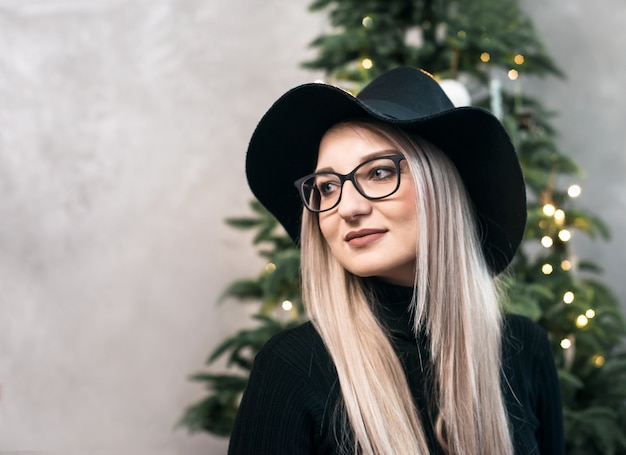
<box><xmin>522</xmin><ymin>0</ymin><xmax>626</xmax><ymax>311</ymax></box>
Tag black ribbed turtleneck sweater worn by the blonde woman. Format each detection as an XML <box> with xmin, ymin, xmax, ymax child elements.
<box><xmin>228</xmin><ymin>282</ymin><xmax>564</xmax><ymax>455</ymax></box>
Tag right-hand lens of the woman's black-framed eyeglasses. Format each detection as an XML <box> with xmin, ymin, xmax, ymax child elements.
<box><xmin>354</xmin><ymin>158</ymin><xmax>400</xmax><ymax>199</ymax></box>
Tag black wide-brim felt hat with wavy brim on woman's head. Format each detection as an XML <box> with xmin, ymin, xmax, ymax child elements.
<box><xmin>246</xmin><ymin>67</ymin><xmax>526</xmax><ymax>274</ymax></box>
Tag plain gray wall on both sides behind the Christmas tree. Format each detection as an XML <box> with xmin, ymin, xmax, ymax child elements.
<box><xmin>0</xmin><ymin>0</ymin><xmax>626</xmax><ymax>455</ymax></box>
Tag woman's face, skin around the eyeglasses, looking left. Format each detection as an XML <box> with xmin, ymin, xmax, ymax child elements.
<box><xmin>316</xmin><ymin>125</ymin><xmax>417</xmax><ymax>286</ymax></box>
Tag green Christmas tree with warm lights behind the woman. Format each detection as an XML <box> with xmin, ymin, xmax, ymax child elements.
<box><xmin>181</xmin><ymin>0</ymin><xmax>626</xmax><ymax>454</ymax></box>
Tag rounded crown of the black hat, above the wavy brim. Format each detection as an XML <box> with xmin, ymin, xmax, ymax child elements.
<box><xmin>357</xmin><ymin>67</ymin><xmax>454</xmax><ymax>121</ymax></box>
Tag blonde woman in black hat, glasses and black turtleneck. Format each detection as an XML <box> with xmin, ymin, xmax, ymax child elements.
<box><xmin>229</xmin><ymin>68</ymin><xmax>564</xmax><ymax>455</ymax></box>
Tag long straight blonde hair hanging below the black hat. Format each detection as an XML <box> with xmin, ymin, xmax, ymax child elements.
<box><xmin>301</xmin><ymin>121</ymin><xmax>513</xmax><ymax>455</ymax></box>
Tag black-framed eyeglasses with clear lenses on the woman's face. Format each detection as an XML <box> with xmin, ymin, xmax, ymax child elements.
<box><xmin>294</xmin><ymin>155</ymin><xmax>404</xmax><ymax>212</ymax></box>
